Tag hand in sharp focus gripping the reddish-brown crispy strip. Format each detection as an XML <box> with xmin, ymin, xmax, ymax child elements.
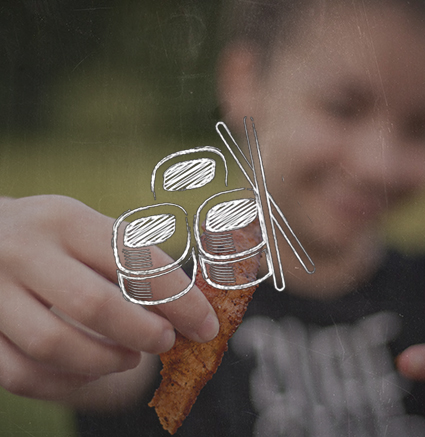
<box><xmin>0</xmin><ymin>196</ymin><xmax>218</xmax><ymax>400</ymax></box>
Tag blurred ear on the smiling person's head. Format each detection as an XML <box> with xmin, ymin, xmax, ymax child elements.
<box><xmin>217</xmin><ymin>43</ymin><xmax>260</xmax><ymax>130</ymax></box>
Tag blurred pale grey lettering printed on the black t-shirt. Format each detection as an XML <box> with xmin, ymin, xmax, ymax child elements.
<box><xmin>232</xmin><ymin>312</ymin><xmax>425</xmax><ymax>437</ymax></box>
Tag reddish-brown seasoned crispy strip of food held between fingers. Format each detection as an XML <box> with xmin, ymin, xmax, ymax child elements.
<box><xmin>149</xmin><ymin>221</ymin><xmax>261</xmax><ymax>434</ymax></box>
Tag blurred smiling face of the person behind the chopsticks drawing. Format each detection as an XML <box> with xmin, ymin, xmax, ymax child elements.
<box><xmin>227</xmin><ymin>2</ymin><xmax>425</xmax><ymax>250</ymax></box>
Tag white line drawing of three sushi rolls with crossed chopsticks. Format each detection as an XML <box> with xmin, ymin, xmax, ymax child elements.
<box><xmin>112</xmin><ymin>117</ymin><xmax>315</xmax><ymax>305</ymax></box>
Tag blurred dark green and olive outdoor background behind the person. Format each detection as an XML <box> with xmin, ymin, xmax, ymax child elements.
<box><xmin>0</xmin><ymin>0</ymin><xmax>425</xmax><ymax>437</ymax></box>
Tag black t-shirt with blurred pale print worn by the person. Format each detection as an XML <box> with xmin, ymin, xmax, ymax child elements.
<box><xmin>77</xmin><ymin>253</ymin><xmax>425</xmax><ymax>437</ymax></box>
